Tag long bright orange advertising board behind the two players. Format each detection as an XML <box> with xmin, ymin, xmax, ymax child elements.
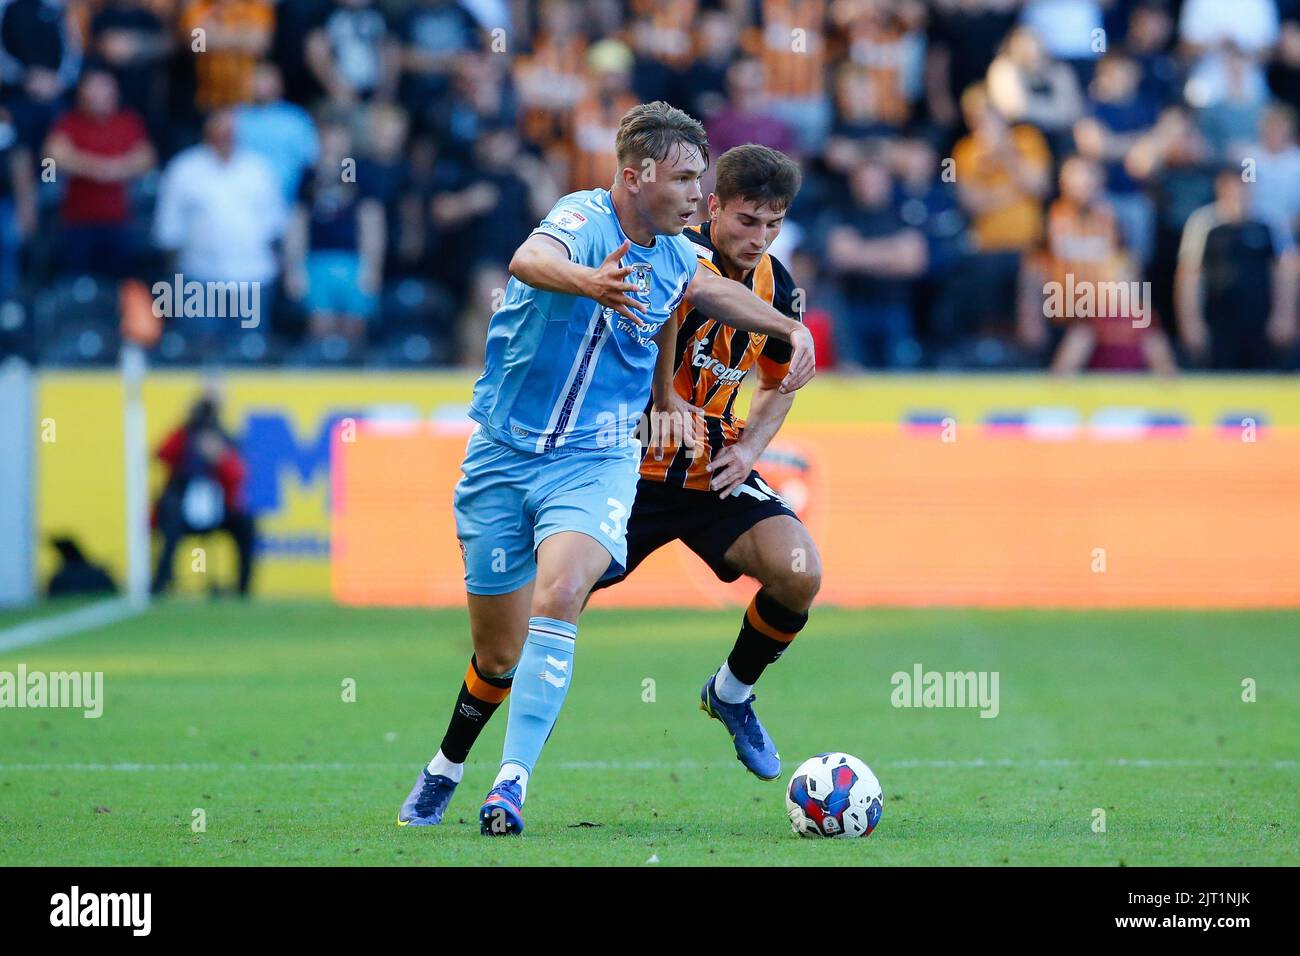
<box><xmin>332</xmin><ymin>423</ymin><xmax>1300</xmax><ymax>607</ymax></box>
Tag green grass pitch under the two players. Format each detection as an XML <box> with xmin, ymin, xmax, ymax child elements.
<box><xmin>0</xmin><ymin>602</ymin><xmax>1300</xmax><ymax>866</ymax></box>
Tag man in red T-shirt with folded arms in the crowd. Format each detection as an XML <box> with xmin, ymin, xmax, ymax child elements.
<box><xmin>46</xmin><ymin>69</ymin><xmax>155</xmax><ymax>278</ymax></box>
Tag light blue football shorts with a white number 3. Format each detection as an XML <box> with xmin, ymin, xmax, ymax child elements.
<box><xmin>454</xmin><ymin>428</ymin><xmax>641</xmax><ymax>594</ymax></box>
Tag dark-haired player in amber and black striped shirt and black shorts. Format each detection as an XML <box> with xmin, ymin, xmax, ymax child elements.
<box><xmin>597</xmin><ymin>146</ymin><xmax>822</xmax><ymax>779</ymax></box>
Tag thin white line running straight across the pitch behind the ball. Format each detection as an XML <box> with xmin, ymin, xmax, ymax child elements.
<box><xmin>0</xmin><ymin>757</ymin><xmax>1300</xmax><ymax>773</ymax></box>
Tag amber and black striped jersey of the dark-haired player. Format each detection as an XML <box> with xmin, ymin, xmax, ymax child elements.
<box><xmin>641</xmin><ymin>222</ymin><xmax>803</xmax><ymax>492</ymax></box>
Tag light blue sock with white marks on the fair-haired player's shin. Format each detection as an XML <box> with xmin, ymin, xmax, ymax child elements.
<box><xmin>501</xmin><ymin>618</ymin><xmax>577</xmax><ymax>774</ymax></box>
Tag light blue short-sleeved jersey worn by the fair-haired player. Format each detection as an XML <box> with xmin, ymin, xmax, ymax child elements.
<box><xmin>469</xmin><ymin>189</ymin><xmax>698</xmax><ymax>454</ymax></box>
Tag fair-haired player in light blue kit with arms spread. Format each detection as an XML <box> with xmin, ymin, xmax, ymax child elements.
<box><xmin>398</xmin><ymin>101</ymin><xmax>815</xmax><ymax>835</ymax></box>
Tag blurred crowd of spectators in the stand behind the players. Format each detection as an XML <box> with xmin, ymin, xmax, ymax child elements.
<box><xmin>0</xmin><ymin>0</ymin><xmax>1300</xmax><ymax>373</ymax></box>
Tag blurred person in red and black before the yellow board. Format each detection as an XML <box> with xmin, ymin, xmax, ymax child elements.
<box><xmin>150</xmin><ymin>395</ymin><xmax>255</xmax><ymax>597</ymax></box>
